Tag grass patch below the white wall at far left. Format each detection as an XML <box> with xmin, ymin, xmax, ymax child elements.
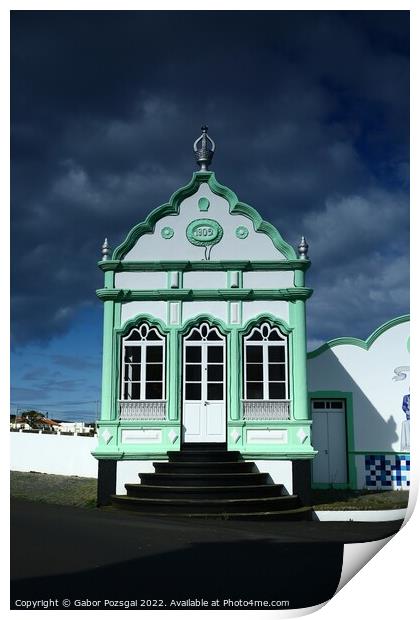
<box><xmin>10</xmin><ymin>471</ymin><xmax>97</xmax><ymax>508</ymax></box>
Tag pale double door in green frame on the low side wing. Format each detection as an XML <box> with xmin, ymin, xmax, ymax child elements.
<box><xmin>311</xmin><ymin>399</ymin><xmax>348</xmax><ymax>484</ymax></box>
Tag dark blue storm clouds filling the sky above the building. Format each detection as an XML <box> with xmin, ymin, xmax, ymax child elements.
<box><xmin>12</xmin><ymin>11</ymin><xmax>409</xmax><ymax>343</ymax></box>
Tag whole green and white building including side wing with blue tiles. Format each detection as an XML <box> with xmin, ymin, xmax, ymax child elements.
<box><xmin>93</xmin><ymin>132</ymin><xmax>410</xmax><ymax>501</ymax></box>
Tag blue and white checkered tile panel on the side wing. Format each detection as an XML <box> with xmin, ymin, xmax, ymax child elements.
<box><xmin>365</xmin><ymin>454</ymin><xmax>410</xmax><ymax>489</ymax></box>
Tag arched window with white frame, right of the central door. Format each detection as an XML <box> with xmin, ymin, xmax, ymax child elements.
<box><xmin>244</xmin><ymin>323</ymin><xmax>289</xmax><ymax>401</ymax></box>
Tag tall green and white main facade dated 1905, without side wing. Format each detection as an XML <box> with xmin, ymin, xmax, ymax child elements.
<box><xmin>94</xmin><ymin>142</ymin><xmax>315</xmax><ymax>498</ymax></box>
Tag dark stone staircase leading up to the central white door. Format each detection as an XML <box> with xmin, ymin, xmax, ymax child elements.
<box><xmin>111</xmin><ymin>444</ymin><xmax>311</xmax><ymax>521</ymax></box>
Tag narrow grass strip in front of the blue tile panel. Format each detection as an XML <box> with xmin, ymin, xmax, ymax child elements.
<box><xmin>312</xmin><ymin>489</ymin><xmax>409</xmax><ymax>510</ymax></box>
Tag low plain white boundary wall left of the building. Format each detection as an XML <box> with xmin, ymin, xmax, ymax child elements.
<box><xmin>10</xmin><ymin>432</ymin><xmax>98</xmax><ymax>478</ymax></box>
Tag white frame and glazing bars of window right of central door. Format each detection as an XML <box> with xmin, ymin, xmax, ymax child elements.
<box><xmin>243</xmin><ymin>323</ymin><xmax>289</xmax><ymax>403</ymax></box>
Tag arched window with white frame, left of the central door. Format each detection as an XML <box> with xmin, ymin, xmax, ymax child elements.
<box><xmin>121</xmin><ymin>323</ymin><xmax>165</xmax><ymax>401</ymax></box>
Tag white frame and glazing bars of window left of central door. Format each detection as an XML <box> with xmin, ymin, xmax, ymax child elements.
<box><xmin>120</xmin><ymin>323</ymin><xmax>166</xmax><ymax>403</ymax></box>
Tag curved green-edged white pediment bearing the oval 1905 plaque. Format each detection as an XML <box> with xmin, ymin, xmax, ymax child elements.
<box><xmin>112</xmin><ymin>171</ymin><xmax>297</xmax><ymax>261</ymax></box>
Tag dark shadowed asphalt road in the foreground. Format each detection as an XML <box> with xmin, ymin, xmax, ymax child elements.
<box><xmin>11</xmin><ymin>500</ymin><xmax>401</xmax><ymax>609</ymax></box>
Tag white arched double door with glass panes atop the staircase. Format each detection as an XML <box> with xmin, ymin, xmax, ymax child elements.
<box><xmin>182</xmin><ymin>326</ymin><xmax>226</xmax><ymax>443</ymax></box>
